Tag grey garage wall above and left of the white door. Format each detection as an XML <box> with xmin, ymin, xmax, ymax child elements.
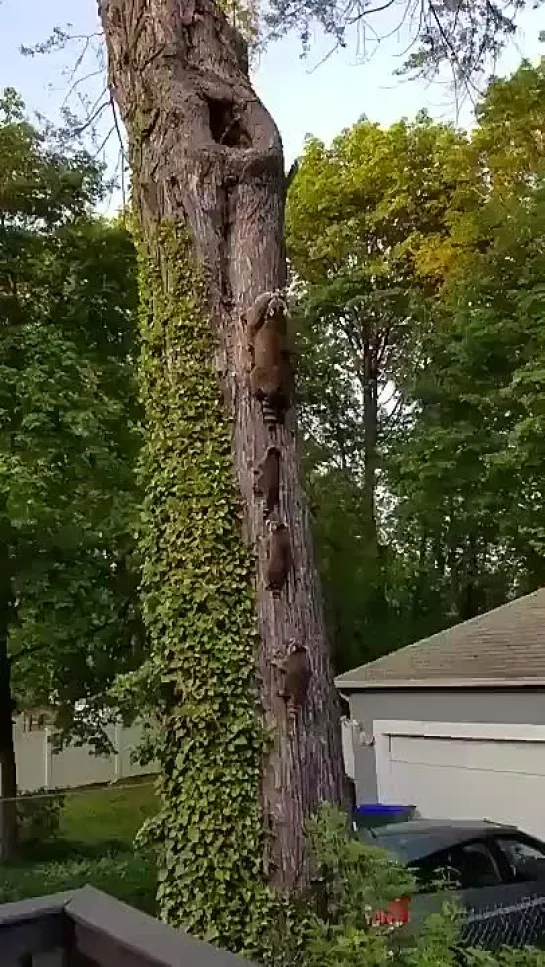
<box><xmin>349</xmin><ymin>688</ymin><xmax>545</xmax><ymax>802</ymax></box>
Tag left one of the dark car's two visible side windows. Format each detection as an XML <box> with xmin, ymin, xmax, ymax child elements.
<box><xmin>413</xmin><ymin>842</ymin><xmax>502</xmax><ymax>891</ymax></box>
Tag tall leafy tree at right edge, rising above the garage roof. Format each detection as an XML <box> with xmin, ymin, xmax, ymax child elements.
<box><xmin>390</xmin><ymin>63</ymin><xmax>545</xmax><ymax>622</ymax></box>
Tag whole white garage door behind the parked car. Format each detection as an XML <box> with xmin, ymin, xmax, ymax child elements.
<box><xmin>374</xmin><ymin>722</ymin><xmax>545</xmax><ymax>839</ymax></box>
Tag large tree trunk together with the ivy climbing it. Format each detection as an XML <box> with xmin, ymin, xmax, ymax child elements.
<box><xmin>101</xmin><ymin>0</ymin><xmax>343</xmax><ymax>949</ymax></box>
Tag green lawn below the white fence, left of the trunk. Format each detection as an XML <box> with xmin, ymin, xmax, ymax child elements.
<box><xmin>0</xmin><ymin>777</ymin><xmax>156</xmax><ymax>913</ymax></box>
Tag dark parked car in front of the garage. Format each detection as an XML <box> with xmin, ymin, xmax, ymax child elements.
<box><xmin>356</xmin><ymin>819</ymin><xmax>545</xmax><ymax>949</ymax></box>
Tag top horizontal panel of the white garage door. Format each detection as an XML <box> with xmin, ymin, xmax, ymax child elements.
<box><xmin>390</xmin><ymin>735</ymin><xmax>545</xmax><ymax>775</ymax></box>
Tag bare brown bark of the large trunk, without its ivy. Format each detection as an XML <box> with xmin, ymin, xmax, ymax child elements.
<box><xmin>102</xmin><ymin>0</ymin><xmax>344</xmax><ymax>930</ymax></box>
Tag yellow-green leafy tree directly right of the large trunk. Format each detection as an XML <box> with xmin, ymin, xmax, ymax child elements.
<box><xmin>287</xmin><ymin>115</ymin><xmax>478</xmax><ymax>668</ymax></box>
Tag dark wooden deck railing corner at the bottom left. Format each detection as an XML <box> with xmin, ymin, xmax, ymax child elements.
<box><xmin>0</xmin><ymin>886</ymin><xmax>251</xmax><ymax>967</ymax></box>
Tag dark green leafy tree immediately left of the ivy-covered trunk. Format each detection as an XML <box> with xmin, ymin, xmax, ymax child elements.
<box><xmin>11</xmin><ymin>219</ymin><xmax>144</xmax><ymax>743</ymax></box>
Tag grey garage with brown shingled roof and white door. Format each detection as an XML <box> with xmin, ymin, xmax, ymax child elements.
<box><xmin>336</xmin><ymin>590</ymin><xmax>545</xmax><ymax>838</ymax></box>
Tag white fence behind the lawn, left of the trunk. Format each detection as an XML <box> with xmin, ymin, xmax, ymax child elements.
<box><xmin>14</xmin><ymin>718</ymin><xmax>157</xmax><ymax>792</ymax></box>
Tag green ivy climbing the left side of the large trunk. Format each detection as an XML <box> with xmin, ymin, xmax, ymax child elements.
<box><xmin>132</xmin><ymin>224</ymin><xmax>264</xmax><ymax>950</ymax></box>
